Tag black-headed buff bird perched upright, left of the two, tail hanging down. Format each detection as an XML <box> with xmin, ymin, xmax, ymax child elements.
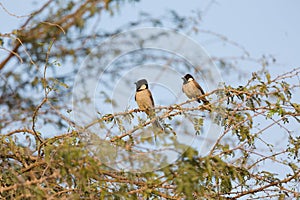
<box><xmin>135</xmin><ymin>79</ymin><xmax>163</xmax><ymax>130</ymax></box>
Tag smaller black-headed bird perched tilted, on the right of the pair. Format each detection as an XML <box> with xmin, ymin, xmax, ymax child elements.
<box><xmin>182</xmin><ymin>74</ymin><xmax>209</xmax><ymax>105</ymax></box>
